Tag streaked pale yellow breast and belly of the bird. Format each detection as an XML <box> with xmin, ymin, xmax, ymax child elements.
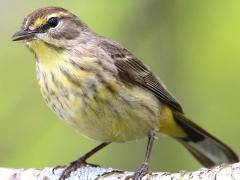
<box><xmin>37</xmin><ymin>58</ymin><xmax>161</xmax><ymax>142</ymax></box>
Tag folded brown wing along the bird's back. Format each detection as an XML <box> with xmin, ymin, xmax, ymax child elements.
<box><xmin>98</xmin><ymin>39</ymin><xmax>183</xmax><ymax>112</ymax></box>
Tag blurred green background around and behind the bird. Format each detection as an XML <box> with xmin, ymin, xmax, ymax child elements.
<box><xmin>0</xmin><ymin>0</ymin><xmax>240</xmax><ymax>171</ymax></box>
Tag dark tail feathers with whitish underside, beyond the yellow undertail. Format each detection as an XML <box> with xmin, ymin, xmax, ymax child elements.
<box><xmin>173</xmin><ymin>112</ymin><xmax>239</xmax><ymax>168</ymax></box>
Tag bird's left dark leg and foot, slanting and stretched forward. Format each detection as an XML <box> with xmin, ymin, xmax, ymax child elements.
<box><xmin>53</xmin><ymin>142</ymin><xmax>110</xmax><ymax>180</ymax></box>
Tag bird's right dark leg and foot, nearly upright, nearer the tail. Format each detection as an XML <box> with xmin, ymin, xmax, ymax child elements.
<box><xmin>126</xmin><ymin>131</ymin><xmax>155</xmax><ymax>180</ymax></box>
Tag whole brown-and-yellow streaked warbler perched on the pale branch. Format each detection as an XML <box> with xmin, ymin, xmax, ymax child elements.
<box><xmin>12</xmin><ymin>7</ymin><xmax>238</xmax><ymax>179</ymax></box>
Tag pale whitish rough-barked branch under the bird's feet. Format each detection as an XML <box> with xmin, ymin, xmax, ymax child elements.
<box><xmin>0</xmin><ymin>163</ymin><xmax>240</xmax><ymax>180</ymax></box>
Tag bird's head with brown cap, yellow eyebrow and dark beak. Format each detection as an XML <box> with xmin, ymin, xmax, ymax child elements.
<box><xmin>12</xmin><ymin>7</ymin><xmax>87</xmax><ymax>50</ymax></box>
